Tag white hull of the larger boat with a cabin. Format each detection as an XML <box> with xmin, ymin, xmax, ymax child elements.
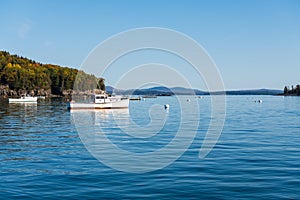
<box><xmin>68</xmin><ymin>99</ymin><xmax>129</xmax><ymax>109</ymax></box>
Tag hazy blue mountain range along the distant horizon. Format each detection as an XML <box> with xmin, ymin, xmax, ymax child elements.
<box><xmin>106</xmin><ymin>86</ymin><xmax>283</xmax><ymax>96</ymax></box>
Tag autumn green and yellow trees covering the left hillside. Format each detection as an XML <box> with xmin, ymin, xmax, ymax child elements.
<box><xmin>0</xmin><ymin>51</ymin><xmax>105</xmax><ymax>95</ymax></box>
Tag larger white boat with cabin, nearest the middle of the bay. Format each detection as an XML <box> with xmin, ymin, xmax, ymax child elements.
<box><xmin>68</xmin><ymin>94</ymin><xmax>129</xmax><ymax>109</ymax></box>
